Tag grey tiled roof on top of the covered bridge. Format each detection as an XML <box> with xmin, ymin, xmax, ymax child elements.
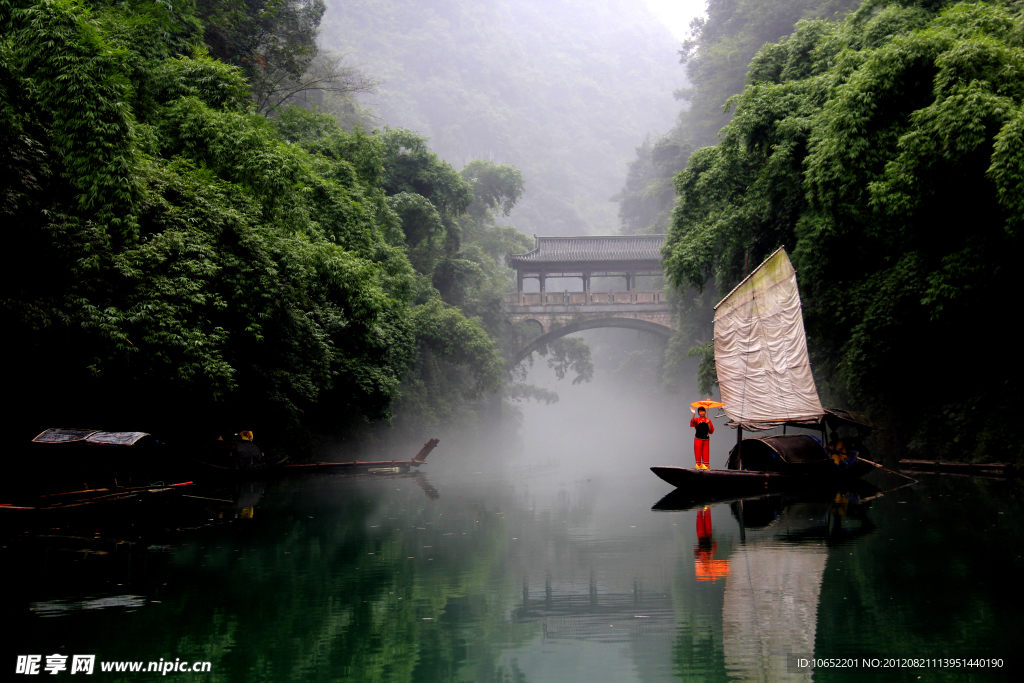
<box><xmin>511</xmin><ymin>234</ymin><xmax>667</xmax><ymax>264</ymax></box>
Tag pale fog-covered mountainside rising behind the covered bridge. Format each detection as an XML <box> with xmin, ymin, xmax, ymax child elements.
<box><xmin>322</xmin><ymin>0</ymin><xmax>684</xmax><ymax>234</ymax></box>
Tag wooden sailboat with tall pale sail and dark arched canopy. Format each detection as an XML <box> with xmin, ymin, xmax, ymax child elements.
<box><xmin>650</xmin><ymin>248</ymin><xmax>876</xmax><ymax>495</ymax></box>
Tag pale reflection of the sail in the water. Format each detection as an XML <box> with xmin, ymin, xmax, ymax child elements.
<box><xmin>722</xmin><ymin>545</ymin><xmax>827</xmax><ymax>682</ymax></box>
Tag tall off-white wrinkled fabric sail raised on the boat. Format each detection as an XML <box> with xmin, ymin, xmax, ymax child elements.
<box><xmin>715</xmin><ymin>249</ymin><xmax>824</xmax><ymax>428</ymax></box>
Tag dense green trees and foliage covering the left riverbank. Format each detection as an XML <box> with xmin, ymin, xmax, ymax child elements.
<box><xmin>0</xmin><ymin>0</ymin><xmax>569</xmax><ymax>445</ymax></box>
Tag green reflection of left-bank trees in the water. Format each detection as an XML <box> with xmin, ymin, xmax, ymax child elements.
<box><xmin>12</xmin><ymin>477</ymin><xmax>539</xmax><ymax>683</ymax></box>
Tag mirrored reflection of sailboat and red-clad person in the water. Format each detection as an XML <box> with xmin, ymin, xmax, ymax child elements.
<box><xmin>653</xmin><ymin>486</ymin><xmax>880</xmax><ymax>682</ymax></box>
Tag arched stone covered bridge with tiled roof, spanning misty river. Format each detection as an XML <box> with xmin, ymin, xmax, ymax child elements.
<box><xmin>505</xmin><ymin>234</ymin><xmax>673</xmax><ymax>365</ymax></box>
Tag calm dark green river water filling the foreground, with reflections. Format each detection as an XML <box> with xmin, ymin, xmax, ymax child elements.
<box><xmin>0</xmin><ymin>449</ymin><xmax>1024</xmax><ymax>682</ymax></box>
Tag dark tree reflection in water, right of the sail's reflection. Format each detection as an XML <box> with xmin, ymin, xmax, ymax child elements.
<box><xmin>815</xmin><ymin>476</ymin><xmax>1024</xmax><ymax>681</ymax></box>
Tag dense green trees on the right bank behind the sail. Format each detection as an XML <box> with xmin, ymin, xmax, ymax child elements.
<box><xmin>666</xmin><ymin>1</ymin><xmax>1024</xmax><ymax>460</ymax></box>
